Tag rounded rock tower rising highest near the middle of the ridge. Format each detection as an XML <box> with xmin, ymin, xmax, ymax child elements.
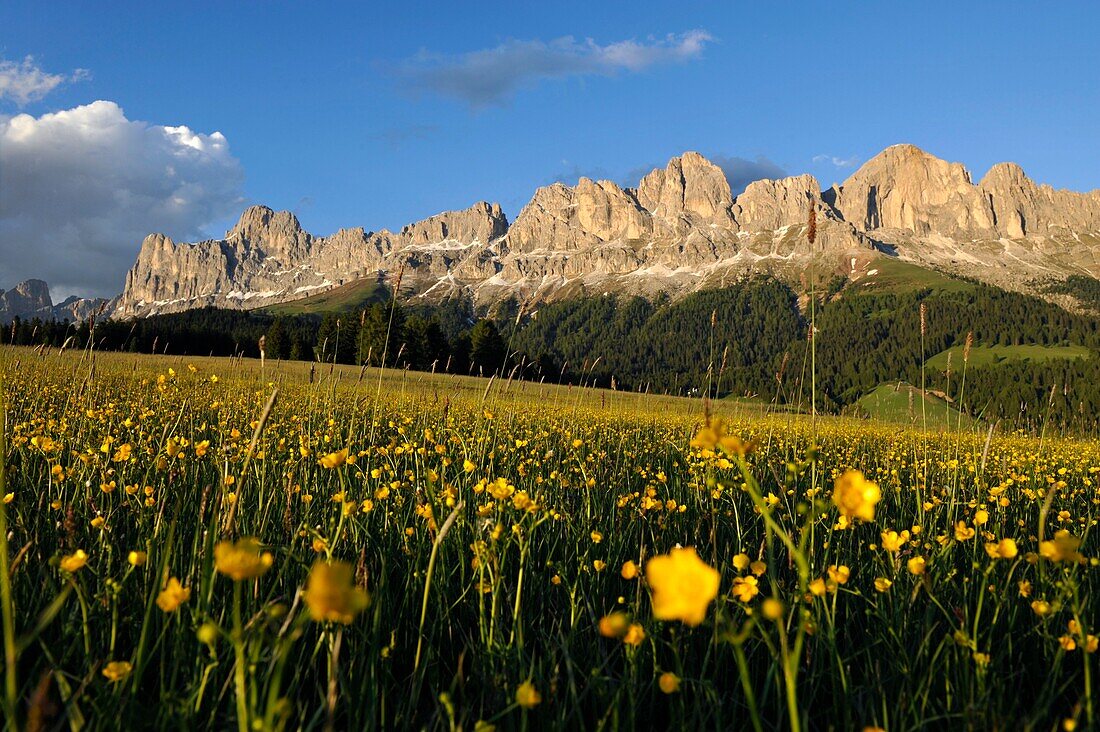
<box><xmin>638</xmin><ymin>152</ymin><xmax>734</xmax><ymax>226</ymax></box>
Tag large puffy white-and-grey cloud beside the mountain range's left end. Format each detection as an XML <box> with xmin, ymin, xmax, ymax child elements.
<box><xmin>0</xmin><ymin>101</ymin><xmax>243</xmax><ymax>299</ymax></box>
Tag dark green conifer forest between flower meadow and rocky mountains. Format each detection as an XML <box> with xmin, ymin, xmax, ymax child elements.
<box><xmin>4</xmin><ymin>277</ymin><xmax>1100</xmax><ymax>429</ymax></box>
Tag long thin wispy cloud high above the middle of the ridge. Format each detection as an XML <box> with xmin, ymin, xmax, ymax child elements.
<box><xmin>398</xmin><ymin>30</ymin><xmax>714</xmax><ymax>107</ymax></box>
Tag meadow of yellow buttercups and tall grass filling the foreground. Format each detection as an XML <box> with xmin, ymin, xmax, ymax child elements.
<box><xmin>0</xmin><ymin>349</ymin><xmax>1100</xmax><ymax>730</ymax></box>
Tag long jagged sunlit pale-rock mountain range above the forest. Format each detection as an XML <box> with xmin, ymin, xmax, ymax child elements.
<box><xmin>109</xmin><ymin>143</ymin><xmax>1100</xmax><ymax>317</ymax></box>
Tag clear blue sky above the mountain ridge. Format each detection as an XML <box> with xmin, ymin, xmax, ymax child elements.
<box><xmin>0</xmin><ymin>0</ymin><xmax>1100</xmax><ymax>292</ymax></box>
